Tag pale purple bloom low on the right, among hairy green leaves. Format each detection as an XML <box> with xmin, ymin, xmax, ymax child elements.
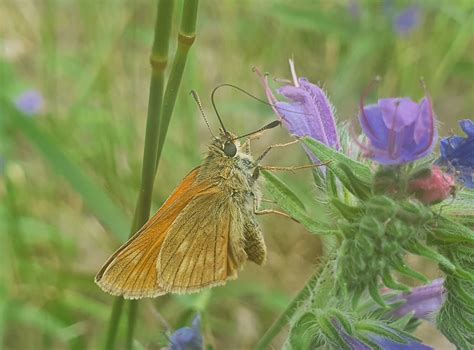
<box><xmin>391</xmin><ymin>278</ymin><xmax>444</xmax><ymax>321</ymax></box>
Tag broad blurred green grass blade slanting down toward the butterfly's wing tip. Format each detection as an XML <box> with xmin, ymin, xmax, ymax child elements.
<box><xmin>0</xmin><ymin>98</ymin><xmax>130</xmax><ymax>241</ymax></box>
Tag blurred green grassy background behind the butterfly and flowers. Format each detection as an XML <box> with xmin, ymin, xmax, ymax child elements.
<box><xmin>0</xmin><ymin>0</ymin><xmax>474</xmax><ymax>349</ymax></box>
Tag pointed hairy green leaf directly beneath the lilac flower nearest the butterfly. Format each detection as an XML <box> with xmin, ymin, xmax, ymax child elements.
<box><xmin>301</xmin><ymin>137</ymin><xmax>372</xmax><ymax>196</ymax></box>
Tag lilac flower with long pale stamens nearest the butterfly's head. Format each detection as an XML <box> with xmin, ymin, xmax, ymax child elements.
<box><xmin>256</xmin><ymin>60</ymin><xmax>340</xmax><ymax>159</ymax></box>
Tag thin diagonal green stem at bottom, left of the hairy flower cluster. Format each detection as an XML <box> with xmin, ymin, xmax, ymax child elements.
<box><xmin>255</xmin><ymin>270</ymin><xmax>321</xmax><ymax>350</ymax></box>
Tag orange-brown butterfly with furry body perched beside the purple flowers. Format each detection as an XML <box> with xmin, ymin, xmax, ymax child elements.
<box><xmin>95</xmin><ymin>115</ymin><xmax>280</xmax><ymax>299</ymax></box>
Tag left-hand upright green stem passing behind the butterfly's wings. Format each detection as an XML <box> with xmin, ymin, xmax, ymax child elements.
<box><xmin>105</xmin><ymin>0</ymin><xmax>174</xmax><ymax>349</ymax></box>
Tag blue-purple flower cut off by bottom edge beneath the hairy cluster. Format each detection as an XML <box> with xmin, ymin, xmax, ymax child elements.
<box><xmin>335</xmin><ymin>323</ymin><xmax>433</xmax><ymax>350</ymax></box>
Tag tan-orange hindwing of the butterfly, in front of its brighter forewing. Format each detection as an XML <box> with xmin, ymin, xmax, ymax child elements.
<box><xmin>157</xmin><ymin>189</ymin><xmax>247</xmax><ymax>293</ymax></box>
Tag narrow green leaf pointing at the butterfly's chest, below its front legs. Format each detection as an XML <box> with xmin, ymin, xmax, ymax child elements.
<box><xmin>261</xmin><ymin>170</ymin><xmax>334</xmax><ymax>235</ymax></box>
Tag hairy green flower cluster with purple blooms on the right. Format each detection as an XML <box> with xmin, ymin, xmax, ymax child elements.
<box><xmin>259</xmin><ymin>61</ymin><xmax>474</xmax><ymax>349</ymax></box>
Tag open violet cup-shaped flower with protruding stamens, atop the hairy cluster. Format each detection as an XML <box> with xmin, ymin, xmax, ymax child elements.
<box><xmin>359</xmin><ymin>97</ymin><xmax>438</xmax><ymax>165</ymax></box>
